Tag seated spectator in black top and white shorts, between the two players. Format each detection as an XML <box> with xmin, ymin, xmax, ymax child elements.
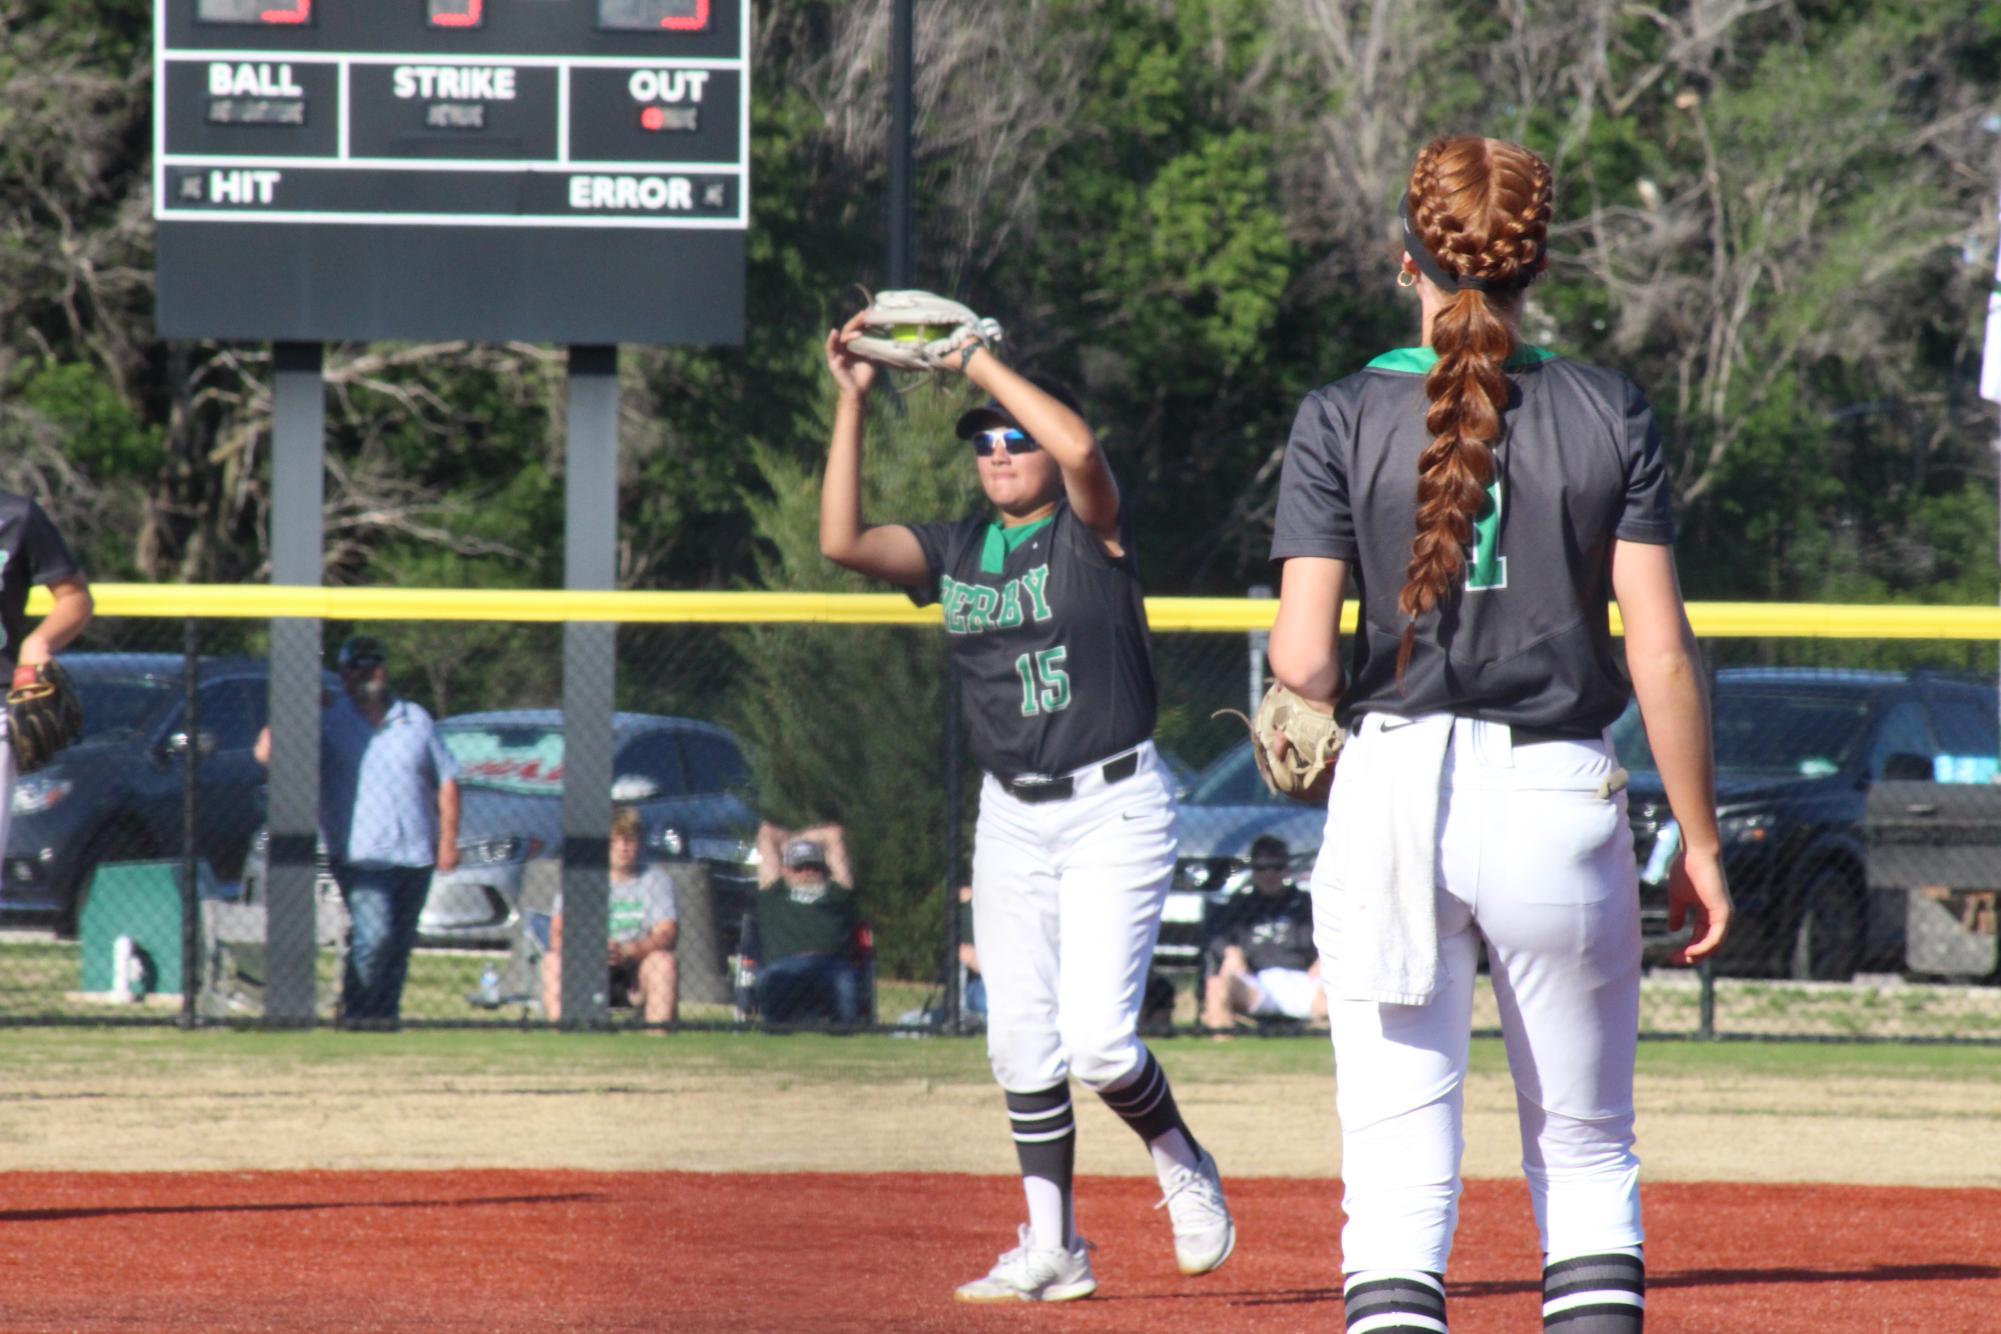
<box><xmin>1203</xmin><ymin>834</ymin><xmax>1327</xmax><ymax>1032</ymax></box>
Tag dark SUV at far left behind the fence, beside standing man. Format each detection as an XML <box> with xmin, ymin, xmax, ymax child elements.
<box><xmin>0</xmin><ymin>654</ymin><xmax>266</xmax><ymax>932</ymax></box>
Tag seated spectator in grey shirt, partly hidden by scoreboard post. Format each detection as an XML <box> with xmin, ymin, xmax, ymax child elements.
<box><xmin>542</xmin><ymin>806</ymin><xmax>680</xmax><ymax>1024</ymax></box>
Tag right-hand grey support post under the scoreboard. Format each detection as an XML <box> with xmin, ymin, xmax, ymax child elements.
<box><xmin>562</xmin><ymin>346</ymin><xmax>618</xmax><ymax>1028</ymax></box>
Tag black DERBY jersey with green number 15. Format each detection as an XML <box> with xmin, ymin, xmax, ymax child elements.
<box><xmin>908</xmin><ymin>500</ymin><xmax>1157</xmax><ymax>778</ymax></box>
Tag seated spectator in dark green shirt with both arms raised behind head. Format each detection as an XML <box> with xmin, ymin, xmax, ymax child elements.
<box><xmin>756</xmin><ymin>820</ymin><xmax>862</xmax><ymax>1024</ymax></box>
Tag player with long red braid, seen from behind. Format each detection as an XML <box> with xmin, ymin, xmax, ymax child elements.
<box><xmin>1271</xmin><ymin>136</ymin><xmax>1731</xmax><ymax>1334</ymax></box>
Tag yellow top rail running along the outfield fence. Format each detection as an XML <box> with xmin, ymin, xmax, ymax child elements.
<box><xmin>28</xmin><ymin>584</ymin><xmax>2001</xmax><ymax>640</ymax></box>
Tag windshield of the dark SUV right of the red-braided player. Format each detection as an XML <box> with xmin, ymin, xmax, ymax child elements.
<box><xmin>1613</xmin><ymin>682</ymin><xmax>1869</xmax><ymax>778</ymax></box>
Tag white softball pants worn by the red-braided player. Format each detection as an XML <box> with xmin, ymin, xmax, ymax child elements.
<box><xmin>1313</xmin><ymin>718</ymin><xmax>1643</xmax><ymax>1274</ymax></box>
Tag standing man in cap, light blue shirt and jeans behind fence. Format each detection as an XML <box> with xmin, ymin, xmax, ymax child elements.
<box><xmin>256</xmin><ymin>634</ymin><xmax>458</xmax><ymax>1028</ymax></box>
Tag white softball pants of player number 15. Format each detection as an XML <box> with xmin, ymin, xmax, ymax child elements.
<box><xmin>972</xmin><ymin>742</ymin><xmax>1181</xmax><ymax>1094</ymax></box>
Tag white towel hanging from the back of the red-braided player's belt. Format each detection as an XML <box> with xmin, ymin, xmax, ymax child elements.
<box><xmin>1333</xmin><ymin>714</ymin><xmax>1453</xmax><ymax>1006</ymax></box>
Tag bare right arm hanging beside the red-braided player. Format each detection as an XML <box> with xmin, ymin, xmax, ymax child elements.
<box><xmin>1613</xmin><ymin>542</ymin><xmax>1731</xmax><ymax>964</ymax></box>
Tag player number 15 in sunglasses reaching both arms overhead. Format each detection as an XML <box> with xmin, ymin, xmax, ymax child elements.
<box><xmin>820</xmin><ymin>306</ymin><xmax>1237</xmax><ymax>1302</ymax></box>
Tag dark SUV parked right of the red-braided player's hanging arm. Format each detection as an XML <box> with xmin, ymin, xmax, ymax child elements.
<box><xmin>1613</xmin><ymin>668</ymin><xmax>2001</xmax><ymax>978</ymax></box>
